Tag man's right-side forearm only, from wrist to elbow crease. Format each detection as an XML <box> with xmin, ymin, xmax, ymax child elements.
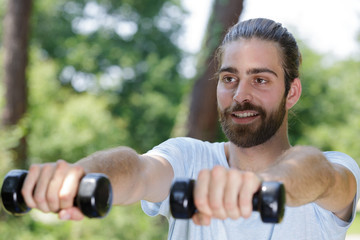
<box><xmin>260</xmin><ymin>147</ymin><xmax>336</xmax><ymax>206</ymax></box>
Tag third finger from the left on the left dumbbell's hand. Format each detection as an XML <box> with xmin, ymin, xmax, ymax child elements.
<box><xmin>46</xmin><ymin>160</ymin><xmax>69</xmax><ymax>212</ymax></box>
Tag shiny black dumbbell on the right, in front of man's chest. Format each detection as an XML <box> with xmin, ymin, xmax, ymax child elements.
<box><xmin>170</xmin><ymin>179</ymin><xmax>285</xmax><ymax>223</ymax></box>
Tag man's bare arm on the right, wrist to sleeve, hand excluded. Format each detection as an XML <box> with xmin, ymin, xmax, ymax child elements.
<box><xmin>260</xmin><ymin>146</ymin><xmax>356</xmax><ymax>220</ymax></box>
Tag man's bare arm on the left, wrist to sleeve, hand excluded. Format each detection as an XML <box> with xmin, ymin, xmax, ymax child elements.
<box><xmin>76</xmin><ymin>147</ymin><xmax>174</xmax><ymax>205</ymax></box>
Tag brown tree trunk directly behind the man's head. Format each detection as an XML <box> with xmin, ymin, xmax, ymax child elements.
<box><xmin>187</xmin><ymin>0</ymin><xmax>243</xmax><ymax>141</ymax></box>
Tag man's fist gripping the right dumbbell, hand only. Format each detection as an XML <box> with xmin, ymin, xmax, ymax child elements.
<box><xmin>192</xmin><ymin>166</ymin><xmax>261</xmax><ymax>225</ymax></box>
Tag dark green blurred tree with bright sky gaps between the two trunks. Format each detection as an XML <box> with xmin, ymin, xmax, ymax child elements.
<box><xmin>26</xmin><ymin>0</ymin><xmax>187</xmax><ymax>152</ymax></box>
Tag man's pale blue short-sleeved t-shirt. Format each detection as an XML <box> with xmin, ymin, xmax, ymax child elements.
<box><xmin>141</xmin><ymin>137</ymin><xmax>360</xmax><ymax>240</ymax></box>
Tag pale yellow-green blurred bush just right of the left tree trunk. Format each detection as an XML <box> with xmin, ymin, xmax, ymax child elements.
<box><xmin>27</xmin><ymin>51</ymin><xmax>127</xmax><ymax>162</ymax></box>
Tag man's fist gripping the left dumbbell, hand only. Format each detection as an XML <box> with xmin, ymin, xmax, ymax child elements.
<box><xmin>21</xmin><ymin>160</ymin><xmax>85</xmax><ymax>220</ymax></box>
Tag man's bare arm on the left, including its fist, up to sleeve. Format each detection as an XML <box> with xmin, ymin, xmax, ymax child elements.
<box><xmin>22</xmin><ymin>147</ymin><xmax>173</xmax><ymax>220</ymax></box>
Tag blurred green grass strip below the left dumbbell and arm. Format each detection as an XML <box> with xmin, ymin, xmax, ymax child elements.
<box><xmin>0</xmin><ymin>204</ymin><xmax>168</xmax><ymax>240</ymax></box>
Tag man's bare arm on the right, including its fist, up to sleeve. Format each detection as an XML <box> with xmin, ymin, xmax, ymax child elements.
<box><xmin>193</xmin><ymin>147</ymin><xmax>356</xmax><ymax>225</ymax></box>
